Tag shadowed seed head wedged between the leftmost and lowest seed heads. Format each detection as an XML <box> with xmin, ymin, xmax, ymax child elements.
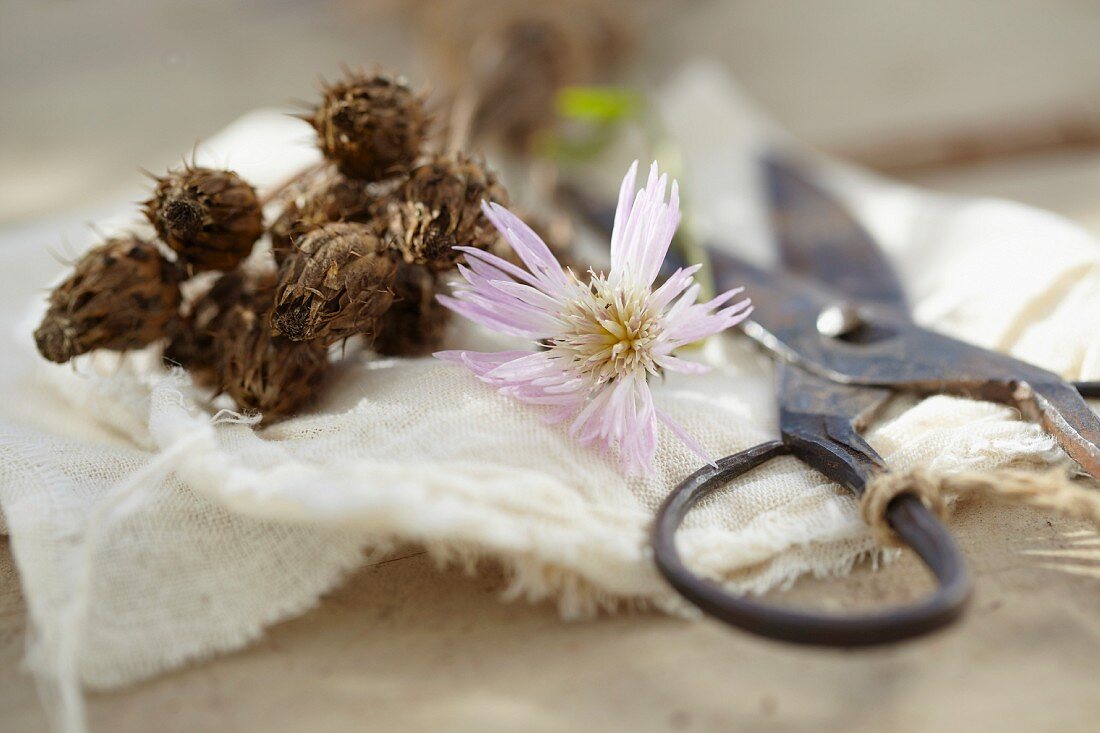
<box><xmin>164</xmin><ymin>266</ymin><xmax>275</xmax><ymax>385</ymax></box>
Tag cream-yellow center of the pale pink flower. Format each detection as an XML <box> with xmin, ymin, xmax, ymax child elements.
<box><xmin>550</xmin><ymin>270</ymin><xmax>661</xmax><ymax>383</ymax></box>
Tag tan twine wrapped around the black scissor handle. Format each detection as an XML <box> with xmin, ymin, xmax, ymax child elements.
<box><xmin>859</xmin><ymin>469</ymin><xmax>1100</xmax><ymax>546</ymax></box>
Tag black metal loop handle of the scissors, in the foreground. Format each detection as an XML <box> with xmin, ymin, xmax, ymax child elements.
<box><xmin>652</xmin><ymin>440</ymin><xmax>970</xmax><ymax>646</ymax></box>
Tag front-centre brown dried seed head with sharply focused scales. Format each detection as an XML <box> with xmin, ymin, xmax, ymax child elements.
<box><xmin>271</xmin><ymin>223</ymin><xmax>397</xmax><ymax>346</ymax></box>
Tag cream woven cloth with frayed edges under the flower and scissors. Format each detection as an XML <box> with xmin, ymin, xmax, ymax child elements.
<box><xmin>0</xmin><ymin>66</ymin><xmax>1100</xmax><ymax>727</ymax></box>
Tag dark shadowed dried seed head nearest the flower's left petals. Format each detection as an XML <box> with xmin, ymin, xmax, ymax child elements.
<box><xmin>374</xmin><ymin>262</ymin><xmax>451</xmax><ymax>357</ymax></box>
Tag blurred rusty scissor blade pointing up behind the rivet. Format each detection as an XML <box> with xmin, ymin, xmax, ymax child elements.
<box><xmin>765</xmin><ymin>154</ymin><xmax>909</xmax><ymax>313</ymax></box>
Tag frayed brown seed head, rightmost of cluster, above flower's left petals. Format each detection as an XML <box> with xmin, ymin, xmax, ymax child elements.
<box><xmin>386</xmin><ymin>153</ymin><xmax>508</xmax><ymax>271</ymax></box>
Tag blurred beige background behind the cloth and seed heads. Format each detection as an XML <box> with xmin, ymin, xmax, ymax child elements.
<box><xmin>0</xmin><ymin>0</ymin><xmax>1100</xmax><ymax>231</ymax></box>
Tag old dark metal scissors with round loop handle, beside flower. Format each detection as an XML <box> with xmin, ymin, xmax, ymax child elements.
<box><xmin>581</xmin><ymin>154</ymin><xmax>1100</xmax><ymax>646</ymax></box>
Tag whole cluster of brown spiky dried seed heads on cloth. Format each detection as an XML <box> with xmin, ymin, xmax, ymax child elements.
<box><xmin>35</xmin><ymin>70</ymin><xmax>550</xmax><ymax>419</ymax></box>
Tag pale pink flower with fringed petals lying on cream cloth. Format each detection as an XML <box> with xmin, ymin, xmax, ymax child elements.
<box><xmin>436</xmin><ymin>162</ymin><xmax>751</xmax><ymax>473</ymax></box>
